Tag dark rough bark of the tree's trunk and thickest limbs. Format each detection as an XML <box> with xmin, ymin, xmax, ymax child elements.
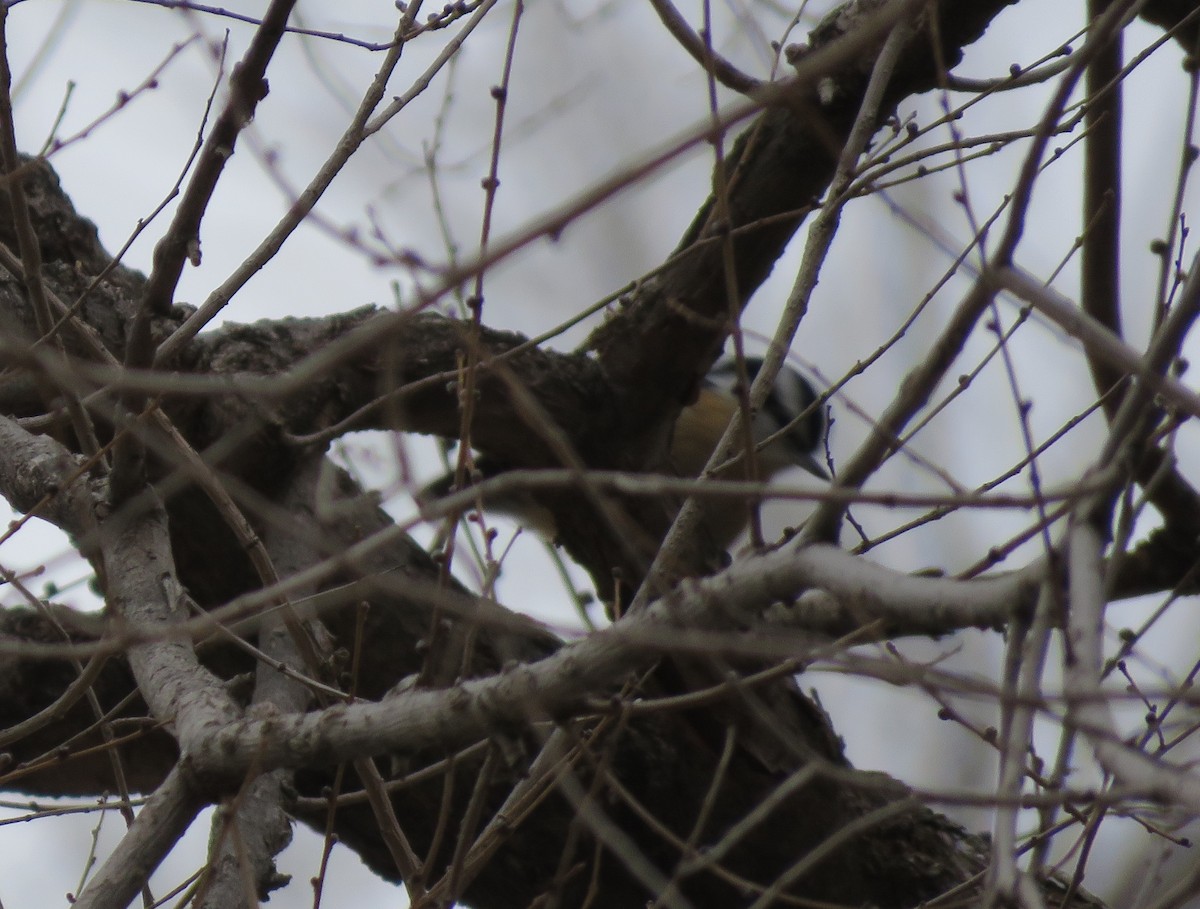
<box><xmin>9</xmin><ymin>0</ymin><xmax>1194</xmax><ymax>909</ymax></box>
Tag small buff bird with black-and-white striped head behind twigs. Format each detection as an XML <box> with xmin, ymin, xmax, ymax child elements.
<box><xmin>422</xmin><ymin>357</ymin><xmax>829</xmax><ymax>548</ymax></box>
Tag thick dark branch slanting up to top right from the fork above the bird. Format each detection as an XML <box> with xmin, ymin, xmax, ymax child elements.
<box><xmin>589</xmin><ymin>0</ymin><xmax>1009</xmax><ymax>457</ymax></box>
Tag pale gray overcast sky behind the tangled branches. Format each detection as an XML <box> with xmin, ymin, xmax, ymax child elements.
<box><xmin>0</xmin><ymin>0</ymin><xmax>1196</xmax><ymax>908</ymax></box>
